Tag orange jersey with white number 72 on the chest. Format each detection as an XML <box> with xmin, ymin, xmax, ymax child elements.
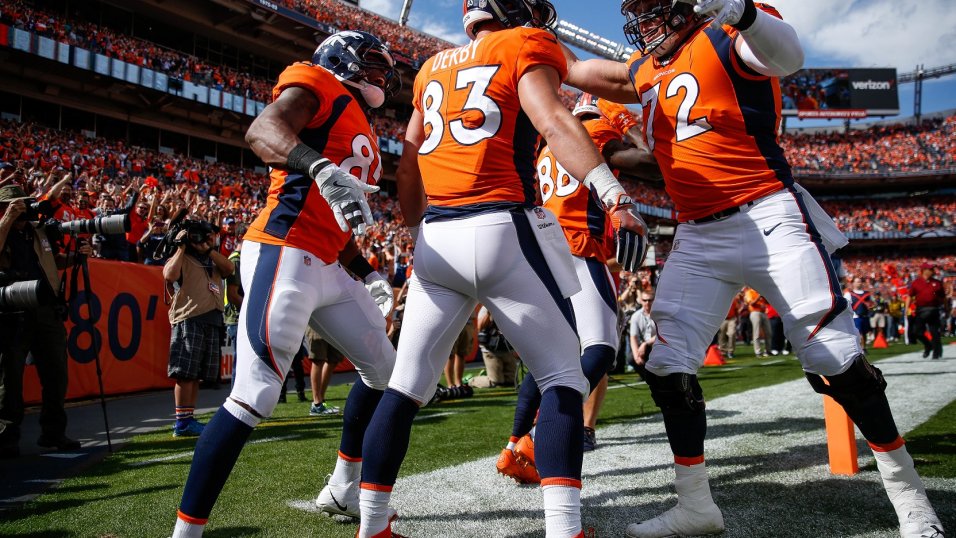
<box><xmin>628</xmin><ymin>6</ymin><xmax>793</xmax><ymax>222</ymax></box>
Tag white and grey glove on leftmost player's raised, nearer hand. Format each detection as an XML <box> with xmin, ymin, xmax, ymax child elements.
<box><xmin>315</xmin><ymin>164</ymin><xmax>379</xmax><ymax>235</ymax></box>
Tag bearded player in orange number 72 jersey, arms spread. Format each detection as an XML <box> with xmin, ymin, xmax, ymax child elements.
<box><xmin>566</xmin><ymin>0</ymin><xmax>942</xmax><ymax>538</ymax></box>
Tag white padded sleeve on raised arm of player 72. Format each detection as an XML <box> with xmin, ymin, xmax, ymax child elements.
<box><xmin>737</xmin><ymin>9</ymin><xmax>803</xmax><ymax>77</ymax></box>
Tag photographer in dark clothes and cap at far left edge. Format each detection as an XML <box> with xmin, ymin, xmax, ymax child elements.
<box><xmin>0</xmin><ymin>185</ymin><xmax>90</xmax><ymax>458</ymax></box>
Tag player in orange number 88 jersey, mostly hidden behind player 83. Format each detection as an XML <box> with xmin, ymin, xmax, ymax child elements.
<box><xmin>496</xmin><ymin>93</ymin><xmax>654</xmax><ymax>483</ymax></box>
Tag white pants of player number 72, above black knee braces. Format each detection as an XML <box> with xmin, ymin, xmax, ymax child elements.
<box><xmin>647</xmin><ymin>189</ymin><xmax>862</xmax><ymax>376</ymax></box>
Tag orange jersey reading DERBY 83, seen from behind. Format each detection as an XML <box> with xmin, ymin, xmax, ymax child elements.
<box><xmin>413</xmin><ymin>28</ymin><xmax>567</xmax><ymax>218</ymax></box>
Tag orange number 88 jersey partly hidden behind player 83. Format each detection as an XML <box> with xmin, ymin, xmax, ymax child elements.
<box><xmin>537</xmin><ymin>117</ymin><xmax>621</xmax><ymax>262</ymax></box>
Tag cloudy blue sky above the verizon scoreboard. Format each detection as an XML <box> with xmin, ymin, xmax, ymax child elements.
<box><xmin>774</xmin><ymin>0</ymin><xmax>956</xmax><ymax>72</ymax></box>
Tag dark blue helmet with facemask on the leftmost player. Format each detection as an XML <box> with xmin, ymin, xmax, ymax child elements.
<box><xmin>312</xmin><ymin>30</ymin><xmax>402</xmax><ymax>108</ymax></box>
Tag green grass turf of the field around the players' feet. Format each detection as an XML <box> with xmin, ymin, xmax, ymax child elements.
<box><xmin>0</xmin><ymin>342</ymin><xmax>956</xmax><ymax>537</ymax></box>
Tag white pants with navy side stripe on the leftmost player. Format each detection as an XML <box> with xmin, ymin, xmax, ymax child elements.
<box><xmin>230</xmin><ymin>241</ymin><xmax>395</xmax><ymax>417</ymax></box>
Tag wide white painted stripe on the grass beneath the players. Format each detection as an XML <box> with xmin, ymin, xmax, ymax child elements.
<box><xmin>378</xmin><ymin>353</ymin><xmax>956</xmax><ymax>538</ymax></box>
